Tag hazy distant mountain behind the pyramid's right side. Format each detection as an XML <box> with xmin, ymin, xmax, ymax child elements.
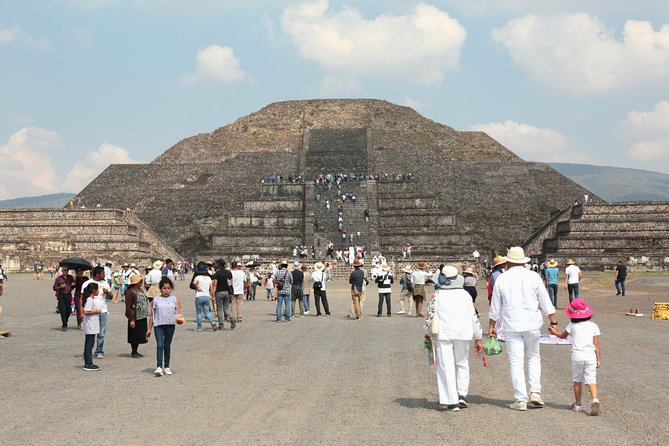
<box><xmin>547</xmin><ymin>163</ymin><xmax>669</xmax><ymax>202</ymax></box>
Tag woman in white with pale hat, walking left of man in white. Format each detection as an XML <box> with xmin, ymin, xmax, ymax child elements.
<box><xmin>425</xmin><ymin>265</ymin><xmax>483</xmax><ymax>411</ymax></box>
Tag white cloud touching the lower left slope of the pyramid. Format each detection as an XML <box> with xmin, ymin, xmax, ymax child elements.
<box><xmin>61</xmin><ymin>143</ymin><xmax>137</xmax><ymax>191</ymax></box>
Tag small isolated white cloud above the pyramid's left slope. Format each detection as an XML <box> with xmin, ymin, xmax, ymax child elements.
<box><xmin>181</xmin><ymin>45</ymin><xmax>246</xmax><ymax>85</ymax></box>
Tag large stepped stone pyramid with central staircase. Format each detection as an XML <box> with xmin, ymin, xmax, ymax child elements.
<box><xmin>72</xmin><ymin>99</ymin><xmax>601</xmax><ymax>259</ymax></box>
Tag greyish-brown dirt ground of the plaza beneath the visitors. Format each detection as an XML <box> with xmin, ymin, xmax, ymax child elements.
<box><xmin>0</xmin><ymin>273</ymin><xmax>669</xmax><ymax>445</ymax></box>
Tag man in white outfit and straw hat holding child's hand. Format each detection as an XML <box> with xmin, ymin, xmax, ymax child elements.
<box><xmin>488</xmin><ymin>246</ymin><xmax>557</xmax><ymax>410</ymax></box>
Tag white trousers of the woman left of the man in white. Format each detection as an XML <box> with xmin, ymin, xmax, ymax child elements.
<box><xmin>432</xmin><ymin>339</ymin><xmax>471</xmax><ymax>404</ymax></box>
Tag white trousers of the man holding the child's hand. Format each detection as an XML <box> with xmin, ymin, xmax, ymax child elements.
<box><xmin>505</xmin><ymin>330</ymin><xmax>541</xmax><ymax>402</ymax></box>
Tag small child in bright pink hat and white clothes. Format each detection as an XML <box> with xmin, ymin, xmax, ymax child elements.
<box><xmin>548</xmin><ymin>298</ymin><xmax>601</xmax><ymax>416</ymax></box>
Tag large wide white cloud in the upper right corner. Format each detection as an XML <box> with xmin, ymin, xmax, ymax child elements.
<box><xmin>492</xmin><ymin>13</ymin><xmax>669</xmax><ymax>94</ymax></box>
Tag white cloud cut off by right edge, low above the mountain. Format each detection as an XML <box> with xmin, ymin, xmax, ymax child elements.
<box><xmin>619</xmin><ymin>101</ymin><xmax>669</xmax><ymax>161</ymax></box>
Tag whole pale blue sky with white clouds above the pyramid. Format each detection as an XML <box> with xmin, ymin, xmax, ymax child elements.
<box><xmin>0</xmin><ymin>0</ymin><xmax>669</xmax><ymax>199</ymax></box>
